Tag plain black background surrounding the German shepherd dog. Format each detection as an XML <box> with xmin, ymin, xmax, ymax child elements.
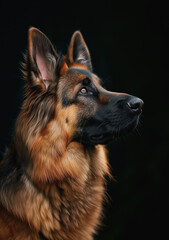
<box><xmin>0</xmin><ymin>0</ymin><xmax>169</xmax><ymax>240</ymax></box>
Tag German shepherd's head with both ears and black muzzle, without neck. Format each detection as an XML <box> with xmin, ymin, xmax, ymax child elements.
<box><xmin>18</xmin><ymin>28</ymin><xmax>143</xmax><ymax>148</ymax></box>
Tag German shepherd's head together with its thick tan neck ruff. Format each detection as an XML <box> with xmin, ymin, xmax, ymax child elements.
<box><xmin>14</xmin><ymin>28</ymin><xmax>143</xmax><ymax>181</ymax></box>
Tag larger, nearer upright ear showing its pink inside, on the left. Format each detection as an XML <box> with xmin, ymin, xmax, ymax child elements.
<box><xmin>28</xmin><ymin>27</ymin><xmax>59</xmax><ymax>88</ymax></box>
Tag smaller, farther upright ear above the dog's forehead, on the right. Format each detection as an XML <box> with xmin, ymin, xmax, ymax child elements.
<box><xmin>68</xmin><ymin>31</ymin><xmax>92</xmax><ymax>71</ymax></box>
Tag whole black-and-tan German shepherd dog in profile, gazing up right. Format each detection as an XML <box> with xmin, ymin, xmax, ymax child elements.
<box><xmin>0</xmin><ymin>27</ymin><xmax>143</xmax><ymax>240</ymax></box>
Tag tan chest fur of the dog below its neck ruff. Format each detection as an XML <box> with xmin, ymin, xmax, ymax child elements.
<box><xmin>37</xmin><ymin>143</ymin><xmax>108</xmax><ymax>240</ymax></box>
